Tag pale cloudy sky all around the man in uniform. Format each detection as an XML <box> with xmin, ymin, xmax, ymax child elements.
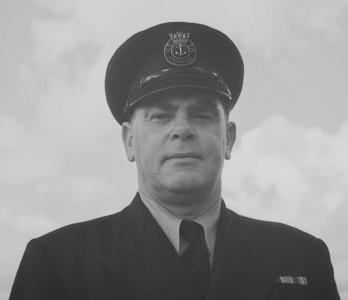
<box><xmin>0</xmin><ymin>0</ymin><xmax>348</xmax><ymax>299</ymax></box>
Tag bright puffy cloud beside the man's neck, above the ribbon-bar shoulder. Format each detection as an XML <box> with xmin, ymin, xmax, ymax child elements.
<box><xmin>224</xmin><ymin>116</ymin><xmax>348</xmax><ymax>225</ymax></box>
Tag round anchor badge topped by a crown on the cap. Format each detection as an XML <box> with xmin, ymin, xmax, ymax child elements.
<box><xmin>164</xmin><ymin>31</ymin><xmax>197</xmax><ymax>66</ymax></box>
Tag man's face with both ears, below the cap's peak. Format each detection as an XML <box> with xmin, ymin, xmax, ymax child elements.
<box><xmin>122</xmin><ymin>91</ymin><xmax>235</xmax><ymax>202</ymax></box>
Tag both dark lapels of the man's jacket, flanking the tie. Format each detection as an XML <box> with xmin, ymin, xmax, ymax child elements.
<box><xmin>100</xmin><ymin>194</ymin><xmax>281</xmax><ymax>300</ymax></box>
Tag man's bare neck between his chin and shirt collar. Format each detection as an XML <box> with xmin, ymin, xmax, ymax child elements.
<box><xmin>139</xmin><ymin>185</ymin><xmax>221</xmax><ymax>220</ymax></box>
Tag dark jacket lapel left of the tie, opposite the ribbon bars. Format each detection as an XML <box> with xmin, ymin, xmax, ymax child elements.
<box><xmin>101</xmin><ymin>194</ymin><xmax>198</xmax><ymax>299</ymax></box>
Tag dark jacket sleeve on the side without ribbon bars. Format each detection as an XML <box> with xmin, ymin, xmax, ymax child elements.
<box><xmin>9</xmin><ymin>239</ymin><xmax>64</xmax><ymax>300</ymax></box>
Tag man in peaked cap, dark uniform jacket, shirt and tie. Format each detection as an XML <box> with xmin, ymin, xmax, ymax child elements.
<box><xmin>10</xmin><ymin>22</ymin><xmax>339</xmax><ymax>300</ymax></box>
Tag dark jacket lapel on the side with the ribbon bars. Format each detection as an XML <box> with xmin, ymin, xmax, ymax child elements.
<box><xmin>208</xmin><ymin>203</ymin><xmax>282</xmax><ymax>300</ymax></box>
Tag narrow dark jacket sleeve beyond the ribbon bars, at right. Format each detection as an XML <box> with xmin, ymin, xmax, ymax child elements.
<box><xmin>308</xmin><ymin>239</ymin><xmax>340</xmax><ymax>300</ymax></box>
